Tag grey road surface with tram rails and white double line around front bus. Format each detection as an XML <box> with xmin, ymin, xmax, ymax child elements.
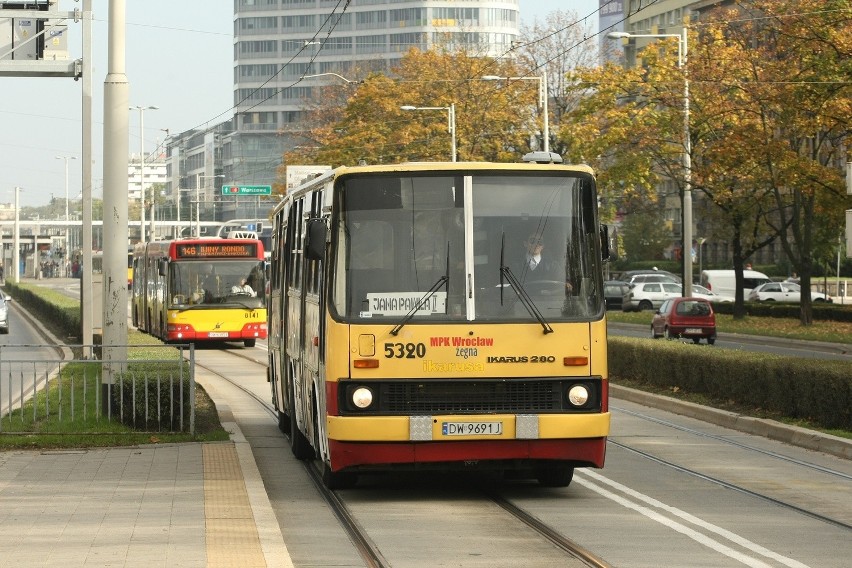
<box><xmin>198</xmin><ymin>346</ymin><xmax>852</xmax><ymax>568</ymax></box>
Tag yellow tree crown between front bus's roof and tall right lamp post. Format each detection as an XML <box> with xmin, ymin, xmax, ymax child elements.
<box><xmin>559</xmin><ymin>45</ymin><xmax>684</xmax><ymax>226</ymax></box>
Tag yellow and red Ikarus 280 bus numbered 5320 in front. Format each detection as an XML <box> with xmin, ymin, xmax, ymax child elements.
<box><xmin>268</xmin><ymin>154</ymin><xmax>610</xmax><ymax>487</ymax></box>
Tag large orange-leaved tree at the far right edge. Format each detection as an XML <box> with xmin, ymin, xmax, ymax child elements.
<box><xmin>690</xmin><ymin>0</ymin><xmax>852</xmax><ymax>325</ymax></box>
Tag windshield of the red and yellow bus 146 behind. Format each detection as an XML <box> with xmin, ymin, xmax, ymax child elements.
<box><xmin>169</xmin><ymin>260</ymin><xmax>266</xmax><ymax>307</ymax></box>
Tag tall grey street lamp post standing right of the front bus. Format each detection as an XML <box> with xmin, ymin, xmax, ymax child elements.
<box><xmin>607</xmin><ymin>25</ymin><xmax>692</xmax><ymax>296</ymax></box>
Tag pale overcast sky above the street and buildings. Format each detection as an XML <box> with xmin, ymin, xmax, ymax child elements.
<box><xmin>0</xmin><ymin>0</ymin><xmax>598</xmax><ymax>206</ymax></box>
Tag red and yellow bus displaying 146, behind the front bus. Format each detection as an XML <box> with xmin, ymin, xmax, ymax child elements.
<box><xmin>131</xmin><ymin>238</ymin><xmax>267</xmax><ymax>347</ymax></box>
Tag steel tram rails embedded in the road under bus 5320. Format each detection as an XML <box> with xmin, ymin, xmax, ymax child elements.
<box><xmin>196</xmin><ymin>350</ymin><xmax>610</xmax><ymax>568</ymax></box>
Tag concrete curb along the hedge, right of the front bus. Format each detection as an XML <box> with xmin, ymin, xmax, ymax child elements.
<box><xmin>609</xmin><ymin>383</ymin><xmax>852</xmax><ymax>460</ymax></box>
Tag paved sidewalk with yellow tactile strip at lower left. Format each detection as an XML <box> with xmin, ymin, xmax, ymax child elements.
<box><xmin>0</xmin><ymin>279</ymin><xmax>292</xmax><ymax>568</ymax></box>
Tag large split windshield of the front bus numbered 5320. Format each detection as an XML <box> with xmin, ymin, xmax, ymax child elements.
<box><xmin>332</xmin><ymin>172</ymin><xmax>604</xmax><ymax>323</ymax></box>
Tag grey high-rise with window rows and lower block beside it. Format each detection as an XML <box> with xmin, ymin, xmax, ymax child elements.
<box><xmin>161</xmin><ymin>0</ymin><xmax>520</xmax><ymax>226</ymax></box>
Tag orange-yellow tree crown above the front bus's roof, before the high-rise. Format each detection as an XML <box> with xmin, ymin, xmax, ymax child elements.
<box><xmin>284</xmin><ymin>50</ymin><xmax>536</xmax><ymax>180</ymax></box>
